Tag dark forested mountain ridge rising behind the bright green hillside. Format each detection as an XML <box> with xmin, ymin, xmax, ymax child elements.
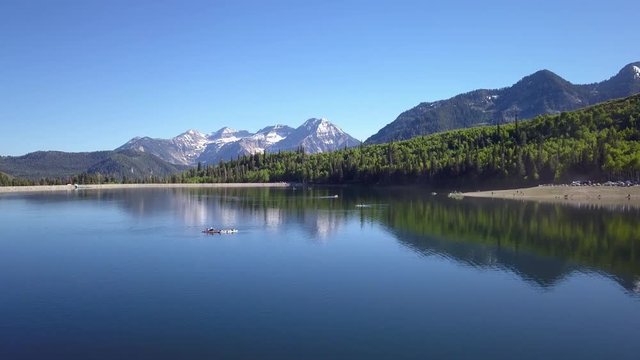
<box><xmin>365</xmin><ymin>62</ymin><xmax>640</xmax><ymax>144</ymax></box>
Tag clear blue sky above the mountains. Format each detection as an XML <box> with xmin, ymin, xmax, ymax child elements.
<box><xmin>0</xmin><ymin>0</ymin><xmax>640</xmax><ymax>155</ymax></box>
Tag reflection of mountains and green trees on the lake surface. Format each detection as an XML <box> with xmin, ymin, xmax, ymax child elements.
<box><xmin>22</xmin><ymin>187</ymin><xmax>640</xmax><ymax>294</ymax></box>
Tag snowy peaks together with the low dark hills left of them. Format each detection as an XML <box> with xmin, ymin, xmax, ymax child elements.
<box><xmin>0</xmin><ymin>118</ymin><xmax>360</xmax><ymax>180</ymax></box>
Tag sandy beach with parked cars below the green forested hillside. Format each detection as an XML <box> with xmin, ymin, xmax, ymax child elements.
<box><xmin>460</xmin><ymin>185</ymin><xmax>640</xmax><ymax>206</ymax></box>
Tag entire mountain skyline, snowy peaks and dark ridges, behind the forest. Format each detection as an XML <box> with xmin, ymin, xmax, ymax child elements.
<box><xmin>0</xmin><ymin>62</ymin><xmax>640</xmax><ymax>180</ymax></box>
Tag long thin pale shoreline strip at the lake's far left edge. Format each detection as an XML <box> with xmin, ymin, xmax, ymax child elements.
<box><xmin>0</xmin><ymin>182</ymin><xmax>293</xmax><ymax>193</ymax></box>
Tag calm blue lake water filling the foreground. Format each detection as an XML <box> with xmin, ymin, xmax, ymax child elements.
<box><xmin>0</xmin><ymin>188</ymin><xmax>640</xmax><ymax>359</ymax></box>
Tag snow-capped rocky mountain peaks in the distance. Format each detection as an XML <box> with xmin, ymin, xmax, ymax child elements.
<box><xmin>117</xmin><ymin>119</ymin><xmax>360</xmax><ymax>165</ymax></box>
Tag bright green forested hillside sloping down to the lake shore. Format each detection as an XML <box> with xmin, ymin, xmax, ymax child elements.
<box><xmin>179</xmin><ymin>95</ymin><xmax>640</xmax><ymax>186</ymax></box>
